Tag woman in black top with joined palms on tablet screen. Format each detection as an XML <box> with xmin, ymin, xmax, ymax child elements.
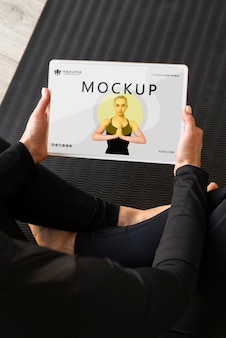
<box><xmin>92</xmin><ymin>95</ymin><xmax>146</xmax><ymax>155</ymax></box>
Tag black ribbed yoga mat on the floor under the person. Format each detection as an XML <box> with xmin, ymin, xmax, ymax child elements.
<box><xmin>0</xmin><ymin>0</ymin><xmax>226</xmax><ymax>208</ymax></box>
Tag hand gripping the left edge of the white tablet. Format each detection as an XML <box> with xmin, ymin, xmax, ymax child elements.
<box><xmin>20</xmin><ymin>88</ymin><xmax>50</xmax><ymax>163</ymax></box>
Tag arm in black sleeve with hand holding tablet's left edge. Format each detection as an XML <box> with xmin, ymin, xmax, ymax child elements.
<box><xmin>0</xmin><ymin>91</ymin><xmax>49</xmax><ymax>202</ymax></box>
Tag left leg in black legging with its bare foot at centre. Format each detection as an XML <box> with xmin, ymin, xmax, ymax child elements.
<box><xmin>0</xmin><ymin>135</ymin><xmax>170</xmax><ymax>240</ymax></box>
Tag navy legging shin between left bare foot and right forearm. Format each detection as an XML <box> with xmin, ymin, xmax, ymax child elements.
<box><xmin>75</xmin><ymin>210</ymin><xmax>168</xmax><ymax>267</ymax></box>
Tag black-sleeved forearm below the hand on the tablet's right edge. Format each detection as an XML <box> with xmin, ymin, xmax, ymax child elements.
<box><xmin>153</xmin><ymin>166</ymin><xmax>208</xmax><ymax>292</ymax></box>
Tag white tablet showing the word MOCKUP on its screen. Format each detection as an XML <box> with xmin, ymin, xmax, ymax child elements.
<box><xmin>48</xmin><ymin>60</ymin><xmax>188</xmax><ymax>164</ymax></box>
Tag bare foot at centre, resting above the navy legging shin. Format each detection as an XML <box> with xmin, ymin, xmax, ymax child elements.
<box><xmin>117</xmin><ymin>204</ymin><xmax>170</xmax><ymax>227</ymax></box>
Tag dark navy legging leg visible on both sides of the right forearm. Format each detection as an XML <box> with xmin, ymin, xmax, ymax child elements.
<box><xmin>75</xmin><ymin>187</ymin><xmax>226</xmax><ymax>338</ymax></box>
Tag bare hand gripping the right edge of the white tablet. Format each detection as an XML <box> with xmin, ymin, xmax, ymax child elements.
<box><xmin>174</xmin><ymin>106</ymin><xmax>203</xmax><ymax>175</ymax></box>
